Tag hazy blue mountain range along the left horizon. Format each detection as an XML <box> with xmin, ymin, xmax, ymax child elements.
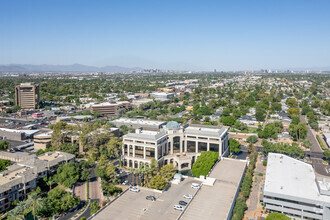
<box><xmin>0</xmin><ymin>64</ymin><xmax>143</xmax><ymax>72</ymax></box>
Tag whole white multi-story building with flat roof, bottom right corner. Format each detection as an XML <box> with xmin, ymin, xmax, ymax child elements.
<box><xmin>263</xmin><ymin>153</ymin><xmax>330</xmax><ymax>220</ymax></box>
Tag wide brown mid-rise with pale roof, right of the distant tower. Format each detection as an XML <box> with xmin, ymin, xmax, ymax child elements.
<box><xmin>90</xmin><ymin>101</ymin><xmax>131</xmax><ymax>115</ymax></box>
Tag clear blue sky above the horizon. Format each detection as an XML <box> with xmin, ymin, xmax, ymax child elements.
<box><xmin>0</xmin><ymin>0</ymin><xmax>330</xmax><ymax>70</ymax></box>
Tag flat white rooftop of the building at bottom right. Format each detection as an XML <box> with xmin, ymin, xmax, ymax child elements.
<box><xmin>264</xmin><ymin>153</ymin><xmax>330</xmax><ymax>204</ymax></box>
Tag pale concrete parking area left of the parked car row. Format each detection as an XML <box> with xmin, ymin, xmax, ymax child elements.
<box><xmin>94</xmin><ymin>179</ymin><xmax>199</xmax><ymax>220</ymax></box>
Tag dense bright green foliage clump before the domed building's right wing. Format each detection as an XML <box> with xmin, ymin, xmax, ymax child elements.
<box><xmin>191</xmin><ymin>151</ymin><xmax>219</xmax><ymax>177</ymax></box>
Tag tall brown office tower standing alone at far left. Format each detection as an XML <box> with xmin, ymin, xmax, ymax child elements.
<box><xmin>15</xmin><ymin>83</ymin><xmax>39</xmax><ymax>109</ymax></box>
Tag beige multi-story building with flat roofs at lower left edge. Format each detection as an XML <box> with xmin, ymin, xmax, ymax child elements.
<box><xmin>0</xmin><ymin>152</ymin><xmax>74</xmax><ymax>212</ymax></box>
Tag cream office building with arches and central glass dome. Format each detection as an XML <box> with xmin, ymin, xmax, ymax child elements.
<box><xmin>122</xmin><ymin>121</ymin><xmax>229</xmax><ymax>170</ymax></box>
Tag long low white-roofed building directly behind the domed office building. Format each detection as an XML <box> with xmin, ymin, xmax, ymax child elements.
<box><xmin>111</xmin><ymin>118</ymin><xmax>166</xmax><ymax>131</ymax></box>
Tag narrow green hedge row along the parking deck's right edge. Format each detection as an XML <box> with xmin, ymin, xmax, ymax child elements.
<box><xmin>231</xmin><ymin>151</ymin><xmax>258</xmax><ymax>220</ymax></box>
